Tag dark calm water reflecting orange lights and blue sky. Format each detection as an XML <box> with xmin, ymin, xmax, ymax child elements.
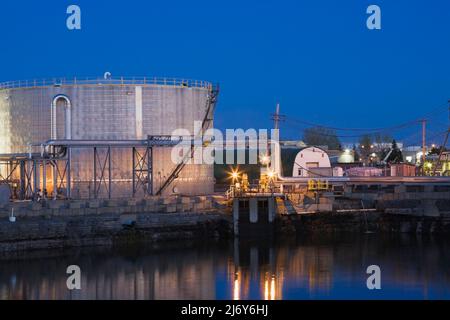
<box><xmin>0</xmin><ymin>235</ymin><xmax>450</xmax><ymax>300</ymax></box>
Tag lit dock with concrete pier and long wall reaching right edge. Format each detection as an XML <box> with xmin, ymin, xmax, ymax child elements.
<box><xmin>227</xmin><ymin>172</ymin><xmax>450</xmax><ymax>237</ymax></box>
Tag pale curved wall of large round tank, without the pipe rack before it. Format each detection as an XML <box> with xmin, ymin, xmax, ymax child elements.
<box><xmin>0</xmin><ymin>77</ymin><xmax>217</xmax><ymax>198</ymax></box>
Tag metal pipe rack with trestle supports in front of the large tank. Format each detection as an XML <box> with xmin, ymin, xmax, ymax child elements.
<box><xmin>0</xmin><ymin>136</ymin><xmax>194</xmax><ymax>200</ymax></box>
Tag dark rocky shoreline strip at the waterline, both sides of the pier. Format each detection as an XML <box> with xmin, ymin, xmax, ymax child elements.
<box><xmin>0</xmin><ymin>205</ymin><xmax>450</xmax><ymax>255</ymax></box>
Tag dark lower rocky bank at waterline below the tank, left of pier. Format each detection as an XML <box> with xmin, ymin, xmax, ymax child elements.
<box><xmin>0</xmin><ymin>212</ymin><xmax>231</xmax><ymax>255</ymax></box>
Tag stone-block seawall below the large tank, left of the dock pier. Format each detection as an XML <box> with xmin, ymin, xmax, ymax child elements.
<box><xmin>0</xmin><ymin>197</ymin><xmax>231</xmax><ymax>252</ymax></box>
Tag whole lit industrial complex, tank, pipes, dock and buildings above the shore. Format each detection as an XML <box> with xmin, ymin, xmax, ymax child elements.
<box><xmin>0</xmin><ymin>74</ymin><xmax>450</xmax><ymax>240</ymax></box>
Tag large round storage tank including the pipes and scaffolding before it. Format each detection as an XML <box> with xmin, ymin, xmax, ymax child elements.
<box><xmin>0</xmin><ymin>74</ymin><xmax>218</xmax><ymax>198</ymax></box>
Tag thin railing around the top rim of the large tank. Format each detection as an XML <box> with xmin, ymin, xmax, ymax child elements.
<box><xmin>0</xmin><ymin>77</ymin><xmax>214</xmax><ymax>90</ymax></box>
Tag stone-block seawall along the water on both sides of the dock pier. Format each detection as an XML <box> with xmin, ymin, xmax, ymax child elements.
<box><xmin>0</xmin><ymin>197</ymin><xmax>450</xmax><ymax>254</ymax></box>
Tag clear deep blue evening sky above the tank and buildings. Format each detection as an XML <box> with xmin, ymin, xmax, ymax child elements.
<box><xmin>0</xmin><ymin>0</ymin><xmax>450</xmax><ymax>142</ymax></box>
